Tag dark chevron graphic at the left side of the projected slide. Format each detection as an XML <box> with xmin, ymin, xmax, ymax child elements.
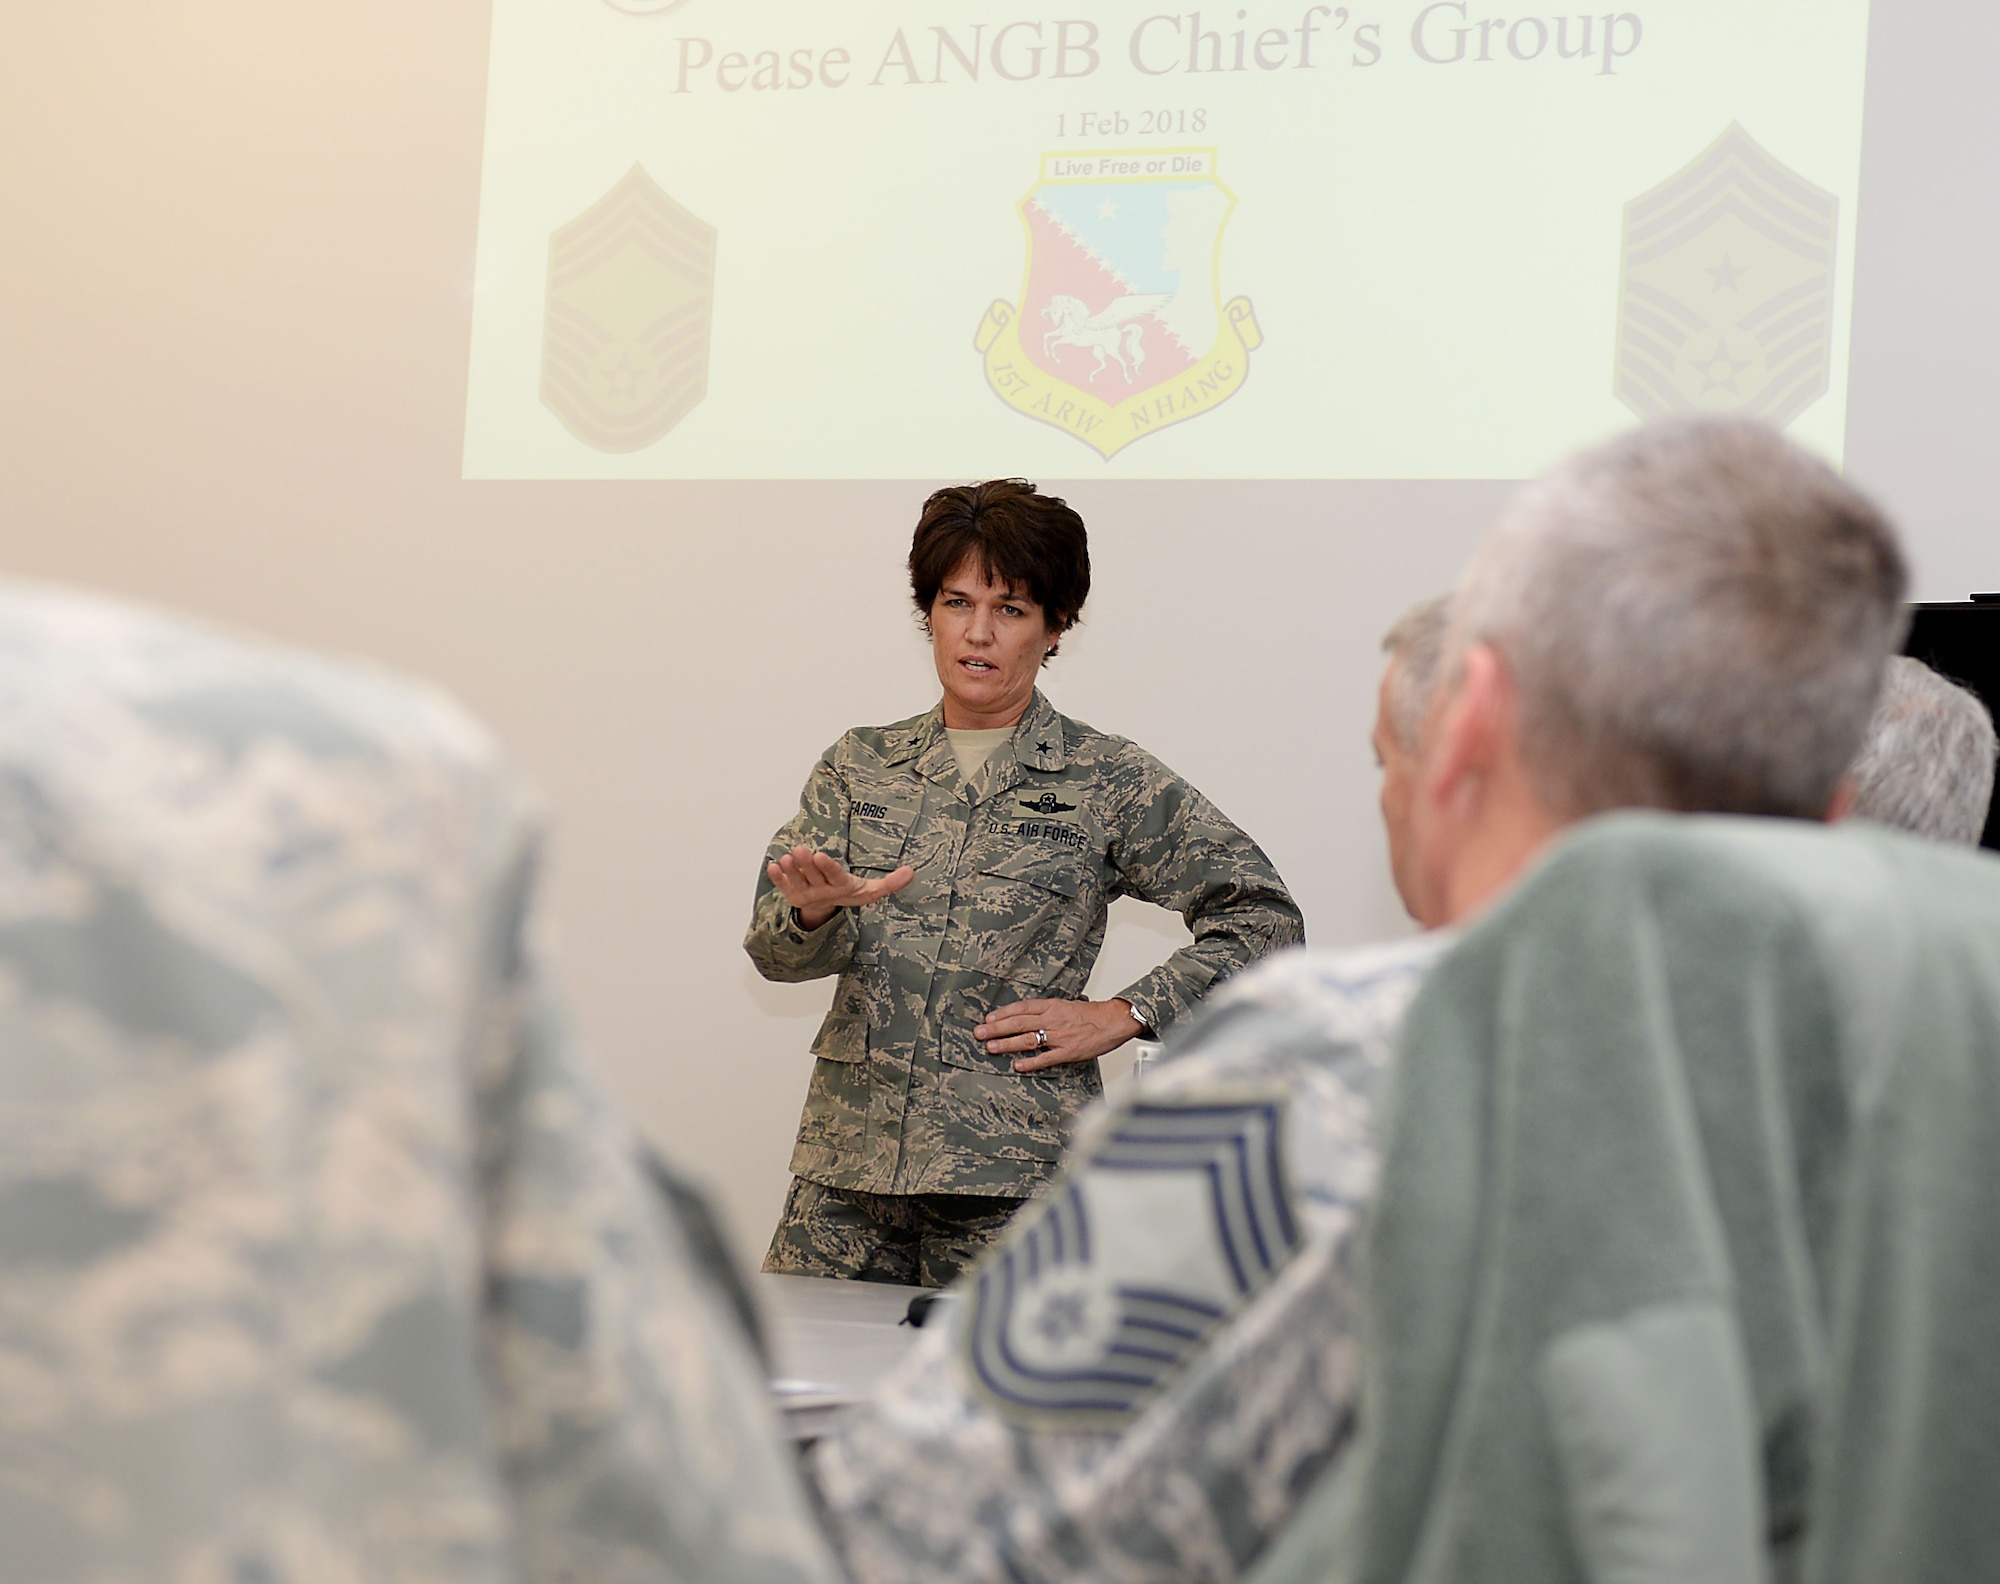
<box><xmin>542</xmin><ymin>166</ymin><xmax>716</xmax><ymax>452</ymax></box>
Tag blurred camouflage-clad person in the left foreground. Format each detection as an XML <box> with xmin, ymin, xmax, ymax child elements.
<box><xmin>0</xmin><ymin>588</ymin><xmax>838</xmax><ymax>1584</ymax></box>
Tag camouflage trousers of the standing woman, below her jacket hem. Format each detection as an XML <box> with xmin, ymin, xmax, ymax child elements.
<box><xmin>764</xmin><ymin>1178</ymin><xmax>1028</xmax><ymax>1286</ymax></box>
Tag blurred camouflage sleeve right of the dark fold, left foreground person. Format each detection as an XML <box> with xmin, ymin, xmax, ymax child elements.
<box><xmin>478</xmin><ymin>836</ymin><xmax>836</xmax><ymax>1584</ymax></box>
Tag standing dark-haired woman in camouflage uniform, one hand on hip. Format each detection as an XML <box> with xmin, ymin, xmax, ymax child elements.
<box><xmin>744</xmin><ymin>480</ymin><xmax>1304</xmax><ymax>1286</ymax></box>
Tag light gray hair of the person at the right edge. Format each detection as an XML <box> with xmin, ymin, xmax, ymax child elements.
<box><xmin>1852</xmin><ymin>654</ymin><xmax>1996</xmax><ymax>844</ymax></box>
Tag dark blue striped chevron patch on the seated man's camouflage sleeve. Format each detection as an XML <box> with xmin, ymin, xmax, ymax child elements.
<box><xmin>958</xmin><ymin>1090</ymin><xmax>1300</xmax><ymax>1430</ymax></box>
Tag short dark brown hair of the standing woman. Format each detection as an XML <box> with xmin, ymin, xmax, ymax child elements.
<box><xmin>910</xmin><ymin>478</ymin><xmax>1090</xmax><ymax>654</ymax></box>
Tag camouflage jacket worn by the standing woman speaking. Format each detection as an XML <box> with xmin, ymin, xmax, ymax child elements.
<box><xmin>744</xmin><ymin>692</ymin><xmax>1304</xmax><ymax>1194</ymax></box>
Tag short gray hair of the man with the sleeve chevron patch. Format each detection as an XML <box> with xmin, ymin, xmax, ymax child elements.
<box><xmin>1446</xmin><ymin>418</ymin><xmax>1908</xmax><ymax>818</ymax></box>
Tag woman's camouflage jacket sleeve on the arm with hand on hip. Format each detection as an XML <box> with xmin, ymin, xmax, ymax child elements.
<box><xmin>1110</xmin><ymin>748</ymin><xmax>1306</xmax><ymax>1034</ymax></box>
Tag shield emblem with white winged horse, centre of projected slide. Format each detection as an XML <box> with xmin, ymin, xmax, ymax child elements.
<box><xmin>972</xmin><ymin>148</ymin><xmax>1264</xmax><ymax>460</ymax></box>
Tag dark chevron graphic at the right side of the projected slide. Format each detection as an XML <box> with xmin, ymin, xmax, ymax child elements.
<box><xmin>1614</xmin><ymin>124</ymin><xmax>1840</xmax><ymax>428</ymax></box>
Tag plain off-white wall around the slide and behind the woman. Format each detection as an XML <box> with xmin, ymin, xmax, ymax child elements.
<box><xmin>0</xmin><ymin>0</ymin><xmax>2000</xmax><ymax>1258</ymax></box>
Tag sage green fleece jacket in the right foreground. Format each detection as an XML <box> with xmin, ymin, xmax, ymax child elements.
<box><xmin>1354</xmin><ymin>814</ymin><xmax>2000</xmax><ymax>1584</ymax></box>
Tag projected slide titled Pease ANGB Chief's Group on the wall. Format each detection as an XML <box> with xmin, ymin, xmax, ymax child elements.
<box><xmin>464</xmin><ymin>0</ymin><xmax>1868</xmax><ymax>478</ymax></box>
